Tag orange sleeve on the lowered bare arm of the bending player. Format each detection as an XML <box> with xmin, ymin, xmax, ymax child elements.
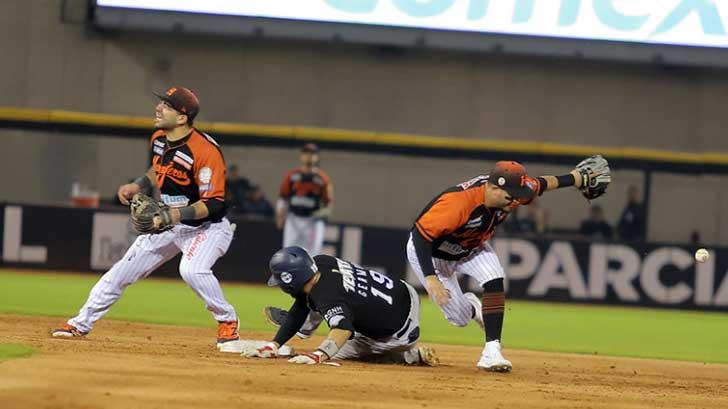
<box><xmin>415</xmin><ymin>192</ymin><xmax>468</xmax><ymax>241</ymax></box>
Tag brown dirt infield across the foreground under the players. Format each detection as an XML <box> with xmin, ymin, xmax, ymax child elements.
<box><xmin>0</xmin><ymin>315</ymin><xmax>728</xmax><ymax>409</ymax></box>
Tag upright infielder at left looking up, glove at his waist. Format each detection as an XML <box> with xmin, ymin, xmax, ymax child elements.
<box><xmin>52</xmin><ymin>86</ymin><xmax>239</xmax><ymax>345</ymax></box>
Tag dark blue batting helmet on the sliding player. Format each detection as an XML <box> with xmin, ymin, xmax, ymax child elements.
<box><xmin>268</xmin><ymin>246</ymin><xmax>318</xmax><ymax>294</ymax></box>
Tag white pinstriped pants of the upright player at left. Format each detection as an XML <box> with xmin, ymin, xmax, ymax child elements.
<box><xmin>68</xmin><ymin>219</ymin><xmax>237</xmax><ymax>332</ymax></box>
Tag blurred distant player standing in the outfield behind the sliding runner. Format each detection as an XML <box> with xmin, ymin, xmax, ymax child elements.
<box><xmin>264</xmin><ymin>143</ymin><xmax>334</xmax><ymax>338</ymax></box>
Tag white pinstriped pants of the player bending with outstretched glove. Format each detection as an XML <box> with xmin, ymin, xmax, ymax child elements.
<box><xmin>407</xmin><ymin>234</ymin><xmax>505</xmax><ymax>327</ymax></box>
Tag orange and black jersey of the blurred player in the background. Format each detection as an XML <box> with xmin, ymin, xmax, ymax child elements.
<box><xmin>279</xmin><ymin>168</ymin><xmax>331</xmax><ymax>217</ymax></box>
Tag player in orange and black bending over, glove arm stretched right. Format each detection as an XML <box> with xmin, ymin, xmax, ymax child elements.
<box><xmin>407</xmin><ymin>156</ymin><xmax>611</xmax><ymax>372</ymax></box>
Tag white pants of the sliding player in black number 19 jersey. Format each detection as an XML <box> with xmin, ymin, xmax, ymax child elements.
<box><xmin>334</xmin><ymin>283</ymin><xmax>420</xmax><ymax>365</ymax></box>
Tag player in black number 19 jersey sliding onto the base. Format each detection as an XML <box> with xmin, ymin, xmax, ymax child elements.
<box><xmin>243</xmin><ymin>247</ymin><xmax>438</xmax><ymax>366</ymax></box>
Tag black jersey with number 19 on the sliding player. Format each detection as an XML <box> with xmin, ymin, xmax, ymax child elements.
<box><xmin>307</xmin><ymin>254</ymin><xmax>412</xmax><ymax>339</ymax></box>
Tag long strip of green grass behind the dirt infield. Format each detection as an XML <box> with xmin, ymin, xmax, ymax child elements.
<box><xmin>0</xmin><ymin>272</ymin><xmax>728</xmax><ymax>363</ymax></box>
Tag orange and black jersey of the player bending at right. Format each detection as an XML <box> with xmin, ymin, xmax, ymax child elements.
<box><xmin>414</xmin><ymin>175</ymin><xmax>543</xmax><ymax>262</ymax></box>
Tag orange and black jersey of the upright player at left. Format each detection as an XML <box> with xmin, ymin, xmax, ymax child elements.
<box><xmin>149</xmin><ymin>129</ymin><xmax>225</xmax><ymax>226</ymax></box>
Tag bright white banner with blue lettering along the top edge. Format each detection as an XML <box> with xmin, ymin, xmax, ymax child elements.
<box><xmin>97</xmin><ymin>0</ymin><xmax>728</xmax><ymax>47</ymax></box>
